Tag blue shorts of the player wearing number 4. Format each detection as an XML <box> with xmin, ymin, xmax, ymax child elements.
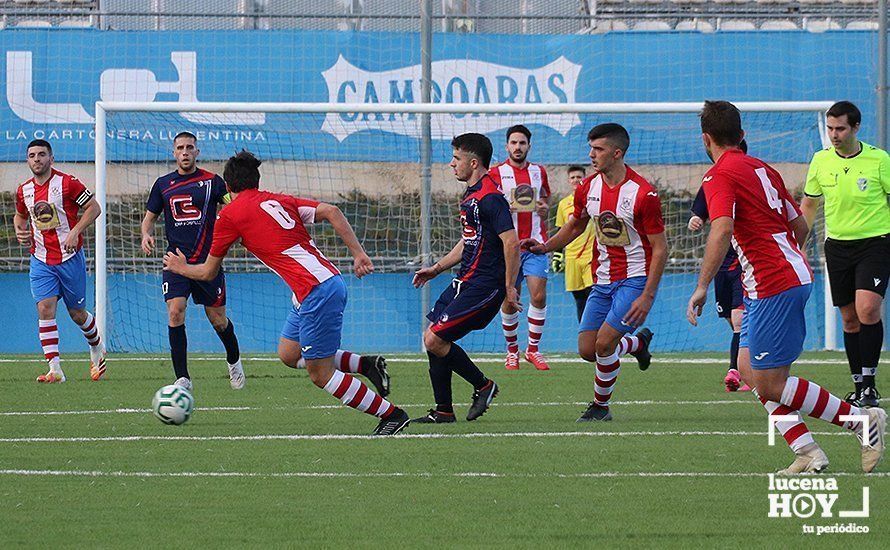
<box><xmin>739</xmin><ymin>284</ymin><xmax>813</xmax><ymax>369</ymax></box>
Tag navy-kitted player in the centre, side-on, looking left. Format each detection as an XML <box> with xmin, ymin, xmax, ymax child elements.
<box><xmin>412</xmin><ymin>134</ymin><xmax>522</xmax><ymax>424</ymax></box>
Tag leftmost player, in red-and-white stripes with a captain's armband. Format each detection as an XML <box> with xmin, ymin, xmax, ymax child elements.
<box><xmin>14</xmin><ymin>139</ymin><xmax>105</xmax><ymax>383</ymax></box>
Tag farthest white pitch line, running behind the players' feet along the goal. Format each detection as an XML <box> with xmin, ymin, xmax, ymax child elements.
<box><xmin>0</xmin><ymin>355</ymin><xmax>847</xmax><ymax>366</ymax></box>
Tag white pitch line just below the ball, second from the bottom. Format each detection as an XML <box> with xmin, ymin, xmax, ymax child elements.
<box><xmin>0</xmin><ymin>431</ymin><xmax>851</xmax><ymax>443</ymax></box>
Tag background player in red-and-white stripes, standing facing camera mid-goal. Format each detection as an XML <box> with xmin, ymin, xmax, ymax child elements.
<box><xmin>489</xmin><ymin>124</ymin><xmax>550</xmax><ymax>370</ymax></box>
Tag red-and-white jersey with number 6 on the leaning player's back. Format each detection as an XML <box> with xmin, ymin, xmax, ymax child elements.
<box><xmin>210</xmin><ymin>189</ymin><xmax>340</xmax><ymax>302</ymax></box>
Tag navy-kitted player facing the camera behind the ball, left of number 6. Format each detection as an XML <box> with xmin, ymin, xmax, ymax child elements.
<box><xmin>142</xmin><ymin>132</ymin><xmax>244</xmax><ymax>390</ymax></box>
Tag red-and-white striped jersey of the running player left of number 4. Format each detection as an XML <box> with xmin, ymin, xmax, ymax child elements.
<box><xmin>572</xmin><ymin>166</ymin><xmax>664</xmax><ymax>285</ymax></box>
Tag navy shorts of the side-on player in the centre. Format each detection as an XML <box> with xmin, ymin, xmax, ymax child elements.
<box><xmin>426</xmin><ymin>279</ymin><xmax>507</xmax><ymax>342</ymax></box>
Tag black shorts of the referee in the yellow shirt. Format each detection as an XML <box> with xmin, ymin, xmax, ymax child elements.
<box><xmin>825</xmin><ymin>235</ymin><xmax>890</xmax><ymax>307</ymax></box>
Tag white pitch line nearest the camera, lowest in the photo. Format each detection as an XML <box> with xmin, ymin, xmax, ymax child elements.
<box><xmin>0</xmin><ymin>469</ymin><xmax>890</xmax><ymax>479</ymax></box>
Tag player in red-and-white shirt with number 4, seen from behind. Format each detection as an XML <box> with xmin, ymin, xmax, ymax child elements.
<box><xmin>686</xmin><ymin>101</ymin><xmax>887</xmax><ymax>474</ymax></box>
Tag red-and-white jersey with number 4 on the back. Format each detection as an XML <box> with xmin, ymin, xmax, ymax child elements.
<box><xmin>702</xmin><ymin>150</ymin><xmax>813</xmax><ymax>299</ymax></box>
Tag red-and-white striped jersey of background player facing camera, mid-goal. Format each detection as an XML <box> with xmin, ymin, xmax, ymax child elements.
<box><xmin>489</xmin><ymin>162</ymin><xmax>550</xmax><ymax>243</ymax></box>
